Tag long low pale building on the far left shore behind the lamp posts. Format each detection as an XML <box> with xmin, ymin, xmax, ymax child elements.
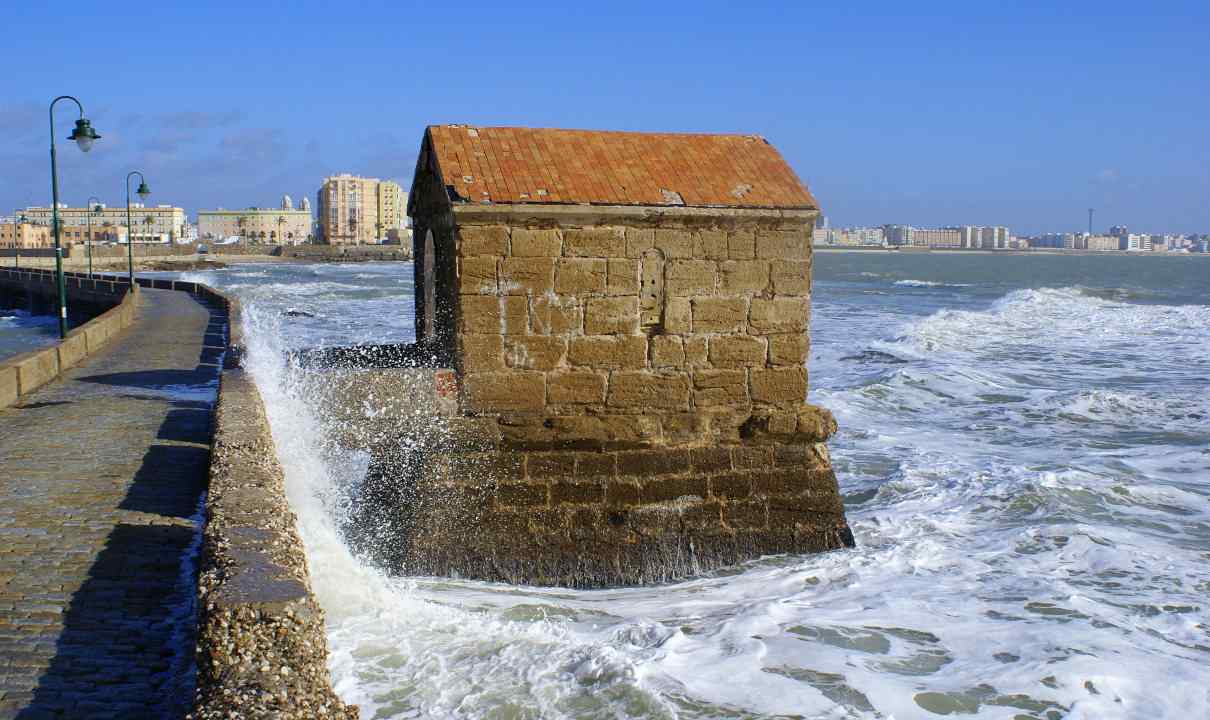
<box><xmin>18</xmin><ymin>203</ymin><xmax>189</xmax><ymax>244</ymax></box>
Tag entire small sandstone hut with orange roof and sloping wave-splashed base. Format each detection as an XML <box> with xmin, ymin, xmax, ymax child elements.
<box><xmin>382</xmin><ymin>125</ymin><xmax>852</xmax><ymax>586</ymax></box>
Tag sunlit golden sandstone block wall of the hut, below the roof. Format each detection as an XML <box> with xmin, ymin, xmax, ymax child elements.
<box><xmin>453</xmin><ymin>220</ymin><xmax>811</xmax><ymax>443</ymax></box>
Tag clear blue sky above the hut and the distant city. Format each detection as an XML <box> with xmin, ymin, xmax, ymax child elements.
<box><xmin>0</xmin><ymin>0</ymin><xmax>1210</xmax><ymax>235</ymax></box>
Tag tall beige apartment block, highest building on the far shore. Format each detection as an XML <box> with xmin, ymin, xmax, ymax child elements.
<box><xmin>316</xmin><ymin>173</ymin><xmax>404</xmax><ymax>244</ymax></box>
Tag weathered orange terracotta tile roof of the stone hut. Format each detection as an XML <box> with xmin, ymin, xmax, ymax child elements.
<box><xmin>427</xmin><ymin>125</ymin><xmax>818</xmax><ymax>209</ymax></box>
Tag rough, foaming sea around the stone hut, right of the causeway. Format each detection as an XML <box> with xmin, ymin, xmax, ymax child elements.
<box><xmin>173</xmin><ymin>252</ymin><xmax>1210</xmax><ymax>720</ymax></box>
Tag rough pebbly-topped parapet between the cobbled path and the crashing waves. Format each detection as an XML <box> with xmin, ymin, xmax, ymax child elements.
<box><xmin>188</xmin><ymin>283</ymin><xmax>358</xmax><ymax>719</ymax></box>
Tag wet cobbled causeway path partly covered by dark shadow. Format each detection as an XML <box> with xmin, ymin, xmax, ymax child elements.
<box><xmin>0</xmin><ymin>289</ymin><xmax>226</xmax><ymax>720</ymax></box>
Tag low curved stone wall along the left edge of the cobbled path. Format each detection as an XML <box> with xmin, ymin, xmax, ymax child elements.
<box><xmin>0</xmin><ymin>270</ymin><xmax>137</xmax><ymax>408</ymax></box>
